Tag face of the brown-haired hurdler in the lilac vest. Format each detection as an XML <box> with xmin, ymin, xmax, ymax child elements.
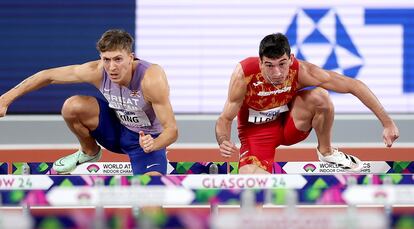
<box><xmin>101</xmin><ymin>50</ymin><xmax>134</xmax><ymax>84</ymax></box>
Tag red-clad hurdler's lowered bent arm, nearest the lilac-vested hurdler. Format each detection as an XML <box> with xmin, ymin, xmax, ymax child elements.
<box><xmin>216</xmin><ymin>64</ymin><xmax>247</xmax><ymax>157</ymax></box>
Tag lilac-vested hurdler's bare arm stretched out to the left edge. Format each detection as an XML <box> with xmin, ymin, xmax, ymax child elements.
<box><xmin>0</xmin><ymin>61</ymin><xmax>99</xmax><ymax>117</ymax></box>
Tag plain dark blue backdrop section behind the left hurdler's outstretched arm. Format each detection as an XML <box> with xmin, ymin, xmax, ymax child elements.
<box><xmin>0</xmin><ymin>0</ymin><xmax>135</xmax><ymax>114</ymax></box>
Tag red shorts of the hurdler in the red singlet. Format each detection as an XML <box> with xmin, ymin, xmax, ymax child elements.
<box><xmin>239</xmin><ymin>112</ymin><xmax>311</xmax><ymax>173</ymax></box>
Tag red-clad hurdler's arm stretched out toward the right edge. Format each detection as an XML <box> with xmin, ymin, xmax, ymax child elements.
<box><xmin>299</xmin><ymin>62</ymin><xmax>399</xmax><ymax>147</ymax></box>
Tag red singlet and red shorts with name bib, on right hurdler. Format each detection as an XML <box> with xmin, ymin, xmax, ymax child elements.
<box><xmin>238</xmin><ymin>57</ymin><xmax>310</xmax><ymax>173</ymax></box>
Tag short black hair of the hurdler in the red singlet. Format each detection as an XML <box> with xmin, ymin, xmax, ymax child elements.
<box><xmin>259</xmin><ymin>33</ymin><xmax>290</xmax><ymax>60</ymax></box>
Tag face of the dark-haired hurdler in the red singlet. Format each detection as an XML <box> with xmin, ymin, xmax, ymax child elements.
<box><xmin>260</xmin><ymin>54</ymin><xmax>292</xmax><ymax>84</ymax></box>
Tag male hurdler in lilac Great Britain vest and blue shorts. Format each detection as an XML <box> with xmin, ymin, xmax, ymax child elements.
<box><xmin>0</xmin><ymin>29</ymin><xmax>178</xmax><ymax>175</ymax></box>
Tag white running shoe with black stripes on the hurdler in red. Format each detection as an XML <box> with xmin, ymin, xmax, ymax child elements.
<box><xmin>316</xmin><ymin>148</ymin><xmax>362</xmax><ymax>172</ymax></box>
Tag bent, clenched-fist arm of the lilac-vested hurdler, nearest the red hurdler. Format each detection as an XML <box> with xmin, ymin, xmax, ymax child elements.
<box><xmin>140</xmin><ymin>65</ymin><xmax>178</xmax><ymax>153</ymax></box>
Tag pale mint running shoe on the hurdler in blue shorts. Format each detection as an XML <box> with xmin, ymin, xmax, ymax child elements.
<box><xmin>53</xmin><ymin>149</ymin><xmax>102</xmax><ymax>174</ymax></box>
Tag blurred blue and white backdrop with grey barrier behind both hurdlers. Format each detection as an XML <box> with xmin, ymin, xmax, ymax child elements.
<box><xmin>0</xmin><ymin>0</ymin><xmax>414</xmax><ymax>144</ymax></box>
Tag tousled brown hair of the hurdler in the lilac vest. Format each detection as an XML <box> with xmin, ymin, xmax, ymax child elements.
<box><xmin>96</xmin><ymin>29</ymin><xmax>134</xmax><ymax>53</ymax></box>
